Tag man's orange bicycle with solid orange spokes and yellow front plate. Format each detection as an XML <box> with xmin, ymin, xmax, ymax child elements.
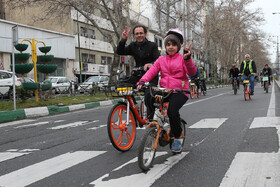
<box><xmin>107</xmin><ymin>87</ymin><xmax>147</xmax><ymax>152</ymax></box>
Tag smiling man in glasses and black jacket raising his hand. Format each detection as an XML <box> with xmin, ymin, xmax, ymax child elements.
<box><xmin>117</xmin><ymin>25</ymin><xmax>160</xmax><ymax>85</ymax></box>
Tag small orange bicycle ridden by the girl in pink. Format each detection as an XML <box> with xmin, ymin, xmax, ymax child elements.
<box><xmin>138</xmin><ymin>87</ymin><xmax>190</xmax><ymax>171</ymax></box>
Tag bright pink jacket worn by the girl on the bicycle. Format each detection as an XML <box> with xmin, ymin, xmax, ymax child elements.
<box><xmin>139</xmin><ymin>53</ymin><xmax>197</xmax><ymax>95</ymax></box>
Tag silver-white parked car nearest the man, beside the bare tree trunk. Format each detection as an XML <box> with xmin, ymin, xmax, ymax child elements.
<box><xmin>78</xmin><ymin>76</ymin><xmax>109</xmax><ymax>92</ymax></box>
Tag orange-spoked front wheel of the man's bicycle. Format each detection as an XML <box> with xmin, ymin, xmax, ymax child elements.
<box><xmin>107</xmin><ymin>103</ymin><xmax>136</xmax><ymax>152</ymax></box>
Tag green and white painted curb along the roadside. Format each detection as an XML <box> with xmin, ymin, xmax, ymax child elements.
<box><xmin>0</xmin><ymin>85</ymin><xmax>228</xmax><ymax>123</ymax></box>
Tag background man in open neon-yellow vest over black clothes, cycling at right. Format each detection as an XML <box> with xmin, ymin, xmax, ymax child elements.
<box><xmin>240</xmin><ymin>54</ymin><xmax>257</xmax><ymax>95</ymax></box>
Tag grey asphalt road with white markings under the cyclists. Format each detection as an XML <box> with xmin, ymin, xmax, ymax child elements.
<box><xmin>0</xmin><ymin>84</ymin><xmax>280</xmax><ymax>187</ymax></box>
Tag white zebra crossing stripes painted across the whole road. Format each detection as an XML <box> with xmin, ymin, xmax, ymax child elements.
<box><xmin>0</xmin><ymin>117</ymin><xmax>280</xmax><ymax>187</ymax></box>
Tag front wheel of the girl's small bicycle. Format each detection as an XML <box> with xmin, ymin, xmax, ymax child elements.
<box><xmin>138</xmin><ymin>127</ymin><xmax>157</xmax><ymax>171</ymax></box>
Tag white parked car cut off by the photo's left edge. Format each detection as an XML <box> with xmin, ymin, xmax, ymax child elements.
<box><xmin>0</xmin><ymin>70</ymin><xmax>21</xmax><ymax>95</ymax></box>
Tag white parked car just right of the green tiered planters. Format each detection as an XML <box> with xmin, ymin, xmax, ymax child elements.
<box><xmin>43</xmin><ymin>77</ymin><xmax>71</xmax><ymax>94</ymax></box>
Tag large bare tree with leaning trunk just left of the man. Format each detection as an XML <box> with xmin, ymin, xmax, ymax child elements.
<box><xmin>6</xmin><ymin>0</ymin><xmax>142</xmax><ymax>80</ymax></box>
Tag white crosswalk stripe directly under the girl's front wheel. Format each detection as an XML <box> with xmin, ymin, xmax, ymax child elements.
<box><xmin>90</xmin><ymin>152</ymin><xmax>188</xmax><ymax>187</ymax></box>
